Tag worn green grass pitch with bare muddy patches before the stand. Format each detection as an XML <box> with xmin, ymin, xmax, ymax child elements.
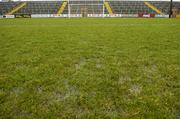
<box><xmin>0</xmin><ymin>19</ymin><xmax>180</xmax><ymax>119</ymax></box>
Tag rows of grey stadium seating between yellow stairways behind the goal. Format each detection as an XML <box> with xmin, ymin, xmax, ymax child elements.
<box><xmin>0</xmin><ymin>0</ymin><xmax>180</xmax><ymax>15</ymax></box>
